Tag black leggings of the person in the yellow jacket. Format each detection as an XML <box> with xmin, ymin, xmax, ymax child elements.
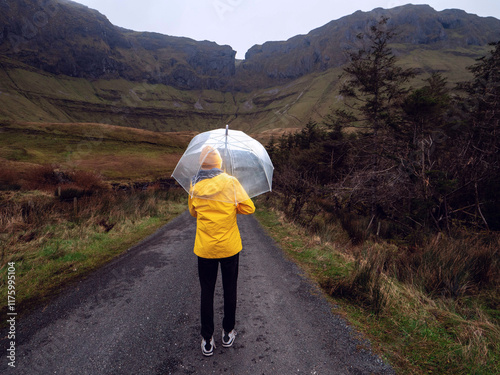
<box><xmin>198</xmin><ymin>253</ymin><xmax>240</xmax><ymax>341</ymax></box>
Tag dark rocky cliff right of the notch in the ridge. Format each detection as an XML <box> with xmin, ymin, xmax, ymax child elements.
<box><xmin>240</xmin><ymin>5</ymin><xmax>500</xmax><ymax>82</ymax></box>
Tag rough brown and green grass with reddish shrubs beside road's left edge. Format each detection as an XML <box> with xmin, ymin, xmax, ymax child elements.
<box><xmin>0</xmin><ymin>178</ymin><xmax>186</xmax><ymax>322</ymax></box>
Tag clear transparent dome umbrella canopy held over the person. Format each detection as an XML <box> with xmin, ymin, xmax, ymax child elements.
<box><xmin>172</xmin><ymin>126</ymin><xmax>274</xmax><ymax>204</ymax></box>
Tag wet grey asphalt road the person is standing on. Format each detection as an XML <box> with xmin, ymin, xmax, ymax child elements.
<box><xmin>0</xmin><ymin>212</ymin><xmax>394</xmax><ymax>375</ymax></box>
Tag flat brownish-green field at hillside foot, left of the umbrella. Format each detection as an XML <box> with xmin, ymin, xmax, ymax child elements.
<box><xmin>0</xmin><ymin>123</ymin><xmax>192</xmax><ymax>180</ymax></box>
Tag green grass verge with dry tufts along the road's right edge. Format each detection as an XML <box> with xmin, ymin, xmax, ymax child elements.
<box><xmin>256</xmin><ymin>204</ymin><xmax>500</xmax><ymax>375</ymax></box>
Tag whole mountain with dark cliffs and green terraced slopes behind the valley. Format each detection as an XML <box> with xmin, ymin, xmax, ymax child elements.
<box><xmin>0</xmin><ymin>0</ymin><xmax>500</xmax><ymax>133</ymax></box>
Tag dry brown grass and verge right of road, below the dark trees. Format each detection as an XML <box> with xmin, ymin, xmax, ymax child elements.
<box><xmin>258</xmin><ymin>200</ymin><xmax>500</xmax><ymax>375</ymax></box>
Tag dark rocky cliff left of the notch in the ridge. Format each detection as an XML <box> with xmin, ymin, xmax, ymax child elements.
<box><xmin>0</xmin><ymin>0</ymin><xmax>236</xmax><ymax>89</ymax></box>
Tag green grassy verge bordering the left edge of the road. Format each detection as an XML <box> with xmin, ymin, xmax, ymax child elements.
<box><xmin>0</xmin><ymin>192</ymin><xmax>186</xmax><ymax>324</ymax></box>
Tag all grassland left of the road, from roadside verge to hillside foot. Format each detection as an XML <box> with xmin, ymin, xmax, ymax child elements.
<box><xmin>0</xmin><ymin>122</ymin><xmax>192</xmax><ymax>320</ymax></box>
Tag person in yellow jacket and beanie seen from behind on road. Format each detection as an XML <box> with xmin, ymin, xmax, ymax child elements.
<box><xmin>188</xmin><ymin>146</ymin><xmax>255</xmax><ymax>356</ymax></box>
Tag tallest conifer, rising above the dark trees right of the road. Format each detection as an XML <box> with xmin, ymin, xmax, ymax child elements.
<box><xmin>334</xmin><ymin>18</ymin><xmax>415</xmax><ymax>226</ymax></box>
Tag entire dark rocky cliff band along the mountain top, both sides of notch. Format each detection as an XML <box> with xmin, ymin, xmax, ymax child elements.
<box><xmin>0</xmin><ymin>0</ymin><xmax>500</xmax><ymax>92</ymax></box>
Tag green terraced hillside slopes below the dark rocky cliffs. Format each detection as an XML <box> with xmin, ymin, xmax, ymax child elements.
<box><xmin>0</xmin><ymin>47</ymin><xmax>488</xmax><ymax>133</ymax></box>
